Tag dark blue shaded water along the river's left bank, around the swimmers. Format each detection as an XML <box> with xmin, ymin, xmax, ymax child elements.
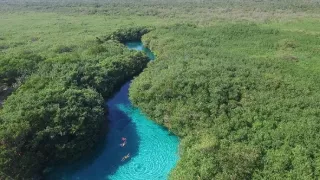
<box><xmin>47</xmin><ymin>82</ymin><xmax>140</xmax><ymax>180</ymax></box>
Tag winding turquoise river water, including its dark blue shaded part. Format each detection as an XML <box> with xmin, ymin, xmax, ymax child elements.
<box><xmin>47</xmin><ymin>42</ymin><xmax>179</xmax><ymax>180</ymax></box>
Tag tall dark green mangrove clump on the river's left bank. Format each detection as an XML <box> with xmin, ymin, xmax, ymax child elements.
<box><xmin>0</xmin><ymin>28</ymin><xmax>148</xmax><ymax>179</ymax></box>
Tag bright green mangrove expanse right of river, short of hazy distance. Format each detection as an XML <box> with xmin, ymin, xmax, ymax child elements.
<box><xmin>130</xmin><ymin>23</ymin><xmax>320</xmax><ymax>179</ymax></box>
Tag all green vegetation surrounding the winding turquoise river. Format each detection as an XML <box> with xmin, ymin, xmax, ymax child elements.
<box><xmin>0</xmin><ymin>0</ymin><xmax>320</xmax><ymax>180</ymax></box>
